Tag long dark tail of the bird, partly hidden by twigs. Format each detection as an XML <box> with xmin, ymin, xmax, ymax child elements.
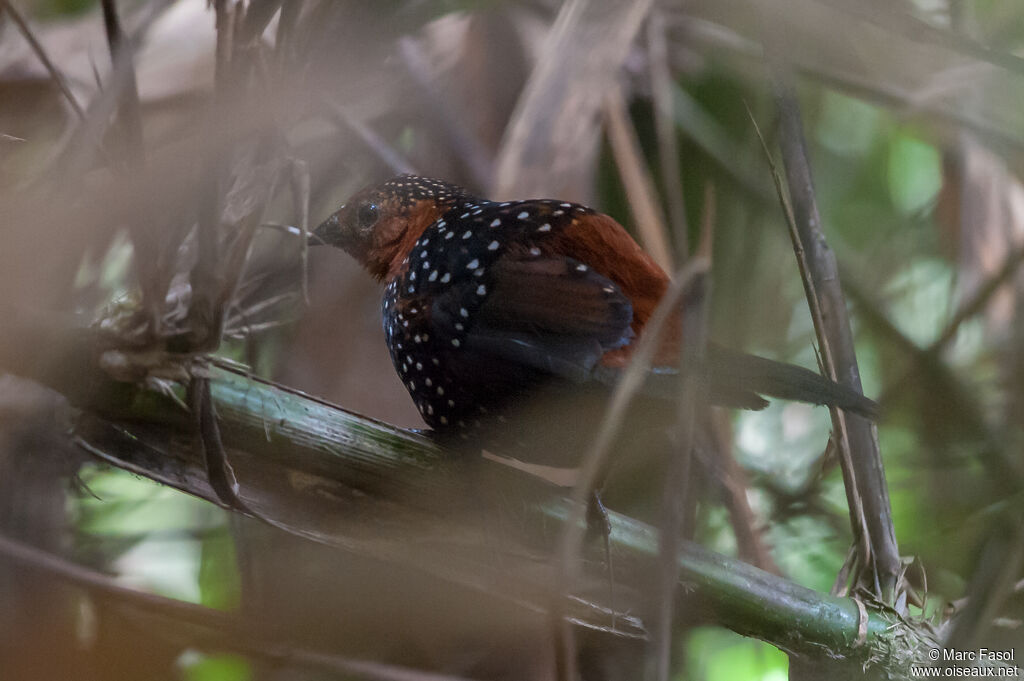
<box><xmin>599</xmin><ymin>344</ymin><xmax>879</xmax><ymax>419</ymax></box>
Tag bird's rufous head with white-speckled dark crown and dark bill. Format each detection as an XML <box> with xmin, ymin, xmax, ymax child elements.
<box><xmin>309</xmin><ymin>175</ymin><xmax>468</xmax><ymax>280</ymax></box>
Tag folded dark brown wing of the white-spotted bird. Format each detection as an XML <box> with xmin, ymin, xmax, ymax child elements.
<box><xmin>431</xmin><ymin>253</ymin><xmax>633</xmax><ymax>382</ymax></box>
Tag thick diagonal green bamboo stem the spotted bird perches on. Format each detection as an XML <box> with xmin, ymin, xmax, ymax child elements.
<box><xmin>0</xmin><ymin>320</ymin><xmax>931</xmax><ymax>678</ymax></box>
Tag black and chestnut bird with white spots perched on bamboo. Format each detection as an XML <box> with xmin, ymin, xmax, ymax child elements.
<box><xmin>310</xmin><ymin>174</ymin><xmax>877</xmax><ymax>462</ymax></box>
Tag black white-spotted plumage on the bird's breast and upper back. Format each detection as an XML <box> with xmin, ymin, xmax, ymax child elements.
<box><xmin>383</xmin><ymin>193</ymin><xmax>618</xmax><ymax>430</ymax></box>
